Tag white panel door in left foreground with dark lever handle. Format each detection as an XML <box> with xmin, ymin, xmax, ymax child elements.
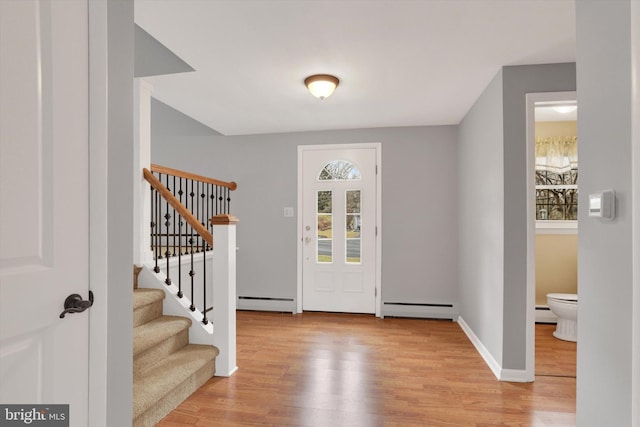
<box><xmin>0</xmin><ymin>0</ymin><xmax>89</xmax><ymax>426</ymax></box>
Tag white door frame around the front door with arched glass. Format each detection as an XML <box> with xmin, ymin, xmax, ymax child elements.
<box><xmin>296</xmin><ymin>142</ymin><xmax>382</xmax><ymax>317</ymax></box>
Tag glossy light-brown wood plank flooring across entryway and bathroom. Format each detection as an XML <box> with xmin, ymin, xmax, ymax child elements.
<box><xmin>158</xmin><ymin>312</ymin><xmax>576</xmax><ymax>427</ymax></box>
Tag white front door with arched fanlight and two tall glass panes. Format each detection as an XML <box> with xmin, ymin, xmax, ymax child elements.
<box><xmin>300</xmin><ymin>145</ymin><xmax>377</xmax><ymax>313</ymax></box>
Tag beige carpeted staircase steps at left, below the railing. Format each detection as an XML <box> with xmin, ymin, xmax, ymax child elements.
<box><xmin>133</xmin><ymin>289</ymin><xmax>218</xmax><ymax>427</ymax></box>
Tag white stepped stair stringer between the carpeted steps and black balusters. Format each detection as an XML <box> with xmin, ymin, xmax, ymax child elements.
<box><xmin>138</xmin><ymin>265</ymin><xmax>214</xmax><ymax>345</ymax></box>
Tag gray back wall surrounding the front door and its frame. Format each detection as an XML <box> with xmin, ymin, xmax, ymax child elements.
<box><xmin>151</xmin><ymin>101</ymin><xmax>458</xmax><ymax>310</ymax></box>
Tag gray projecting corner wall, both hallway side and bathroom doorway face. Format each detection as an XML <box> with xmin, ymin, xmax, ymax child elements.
<box><xmin>459</xmin><ymin>64</ymin><xmax>576</xmax><ymax>370</ymax></box>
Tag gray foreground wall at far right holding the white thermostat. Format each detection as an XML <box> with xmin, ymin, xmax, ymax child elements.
<box><xmin>576</xmin><ymin>0</ymin><xmax>640</xmax><ymax>426</ymax></box>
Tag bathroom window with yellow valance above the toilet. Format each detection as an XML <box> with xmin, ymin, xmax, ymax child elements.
<box><xmin>536</xmin><ymin>136</ymin><xmax>578</xmax><ymax>222</ymax></box>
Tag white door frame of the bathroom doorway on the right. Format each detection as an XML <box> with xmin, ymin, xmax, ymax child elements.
<box><xmin>525</xmin><ymin>91</ymin><xmax>580</xmax><ymax>381</ymax></box>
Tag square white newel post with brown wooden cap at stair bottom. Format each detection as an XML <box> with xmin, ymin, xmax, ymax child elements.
<box><xmin>209</xmin><ymin>215</ymin><xmax>238</xmax><ymax>377</ymax></box>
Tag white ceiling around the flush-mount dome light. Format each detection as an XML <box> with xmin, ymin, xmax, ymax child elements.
<box><xmin>135</xmin><ymin>0</ymin><xmax>575</xmax><ymax>135</ymax></box>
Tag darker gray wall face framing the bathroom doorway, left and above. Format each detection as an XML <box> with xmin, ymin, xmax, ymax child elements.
<box><xmin>502</xmin><ymin>63</ymin><xmax>582</xmax><ymax>370</ymax></box>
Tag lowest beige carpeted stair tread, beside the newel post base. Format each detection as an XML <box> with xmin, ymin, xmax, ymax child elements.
<box><xmin>133</xmin><ymin>344</ymin><xmax>218</xmax><ymax>420</ymax></box>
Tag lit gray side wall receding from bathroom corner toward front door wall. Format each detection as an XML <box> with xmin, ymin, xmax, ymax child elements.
<box><xmin>458</xmin><ymin>71</ymin><xmax>504</xmax><ymax>365</ymax></box>
